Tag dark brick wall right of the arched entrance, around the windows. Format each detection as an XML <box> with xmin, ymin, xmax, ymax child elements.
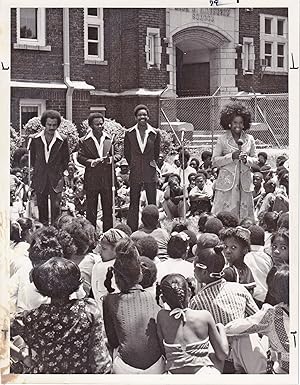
<box><xmin>236</xmin><ymin>8</ymin><xmax>288</xmax><ymax>93</ymax></box>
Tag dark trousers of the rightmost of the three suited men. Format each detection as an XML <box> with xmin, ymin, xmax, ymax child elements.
<box><xmin>127</xmin><ymin>182</ymin><xmax>156</xmax><ymax>231</ymax></box>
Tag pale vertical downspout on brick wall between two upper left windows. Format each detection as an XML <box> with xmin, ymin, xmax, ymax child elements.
<box><xmin>63</xmin><ymin>8</ymin><xmax>74</xmax><ymax>121</ymax></box>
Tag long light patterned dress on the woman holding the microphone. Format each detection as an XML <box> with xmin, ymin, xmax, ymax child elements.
<box><xmin>212</xmin><ymin>131</ymin><xmax>257</xmax><ymax>220</ymax></box>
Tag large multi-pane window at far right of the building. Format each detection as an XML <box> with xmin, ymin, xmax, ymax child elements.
<box><xmin>260</xmin><ymin>14</ymin><xmax>288</xmax><ymax>73</ymax></box>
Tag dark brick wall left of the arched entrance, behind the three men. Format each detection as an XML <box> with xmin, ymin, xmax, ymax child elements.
<box><xmin>11</xmin><ymin>8</ymin><xmax>167</xmax><ymax>127</ymax></box>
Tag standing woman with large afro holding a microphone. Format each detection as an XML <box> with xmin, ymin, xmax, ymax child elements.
<box><xmin>212</xmin><ymin>103</ymin><xmax>258</xmax><ymax>220</ymax></box>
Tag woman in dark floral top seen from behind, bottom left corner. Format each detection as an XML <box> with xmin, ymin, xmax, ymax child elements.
<box><xmin>11</xmin><ymin>257</ymin><xmax>111</xmax><ymax>374</ymax></box>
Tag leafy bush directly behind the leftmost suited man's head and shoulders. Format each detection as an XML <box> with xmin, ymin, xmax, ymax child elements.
<box><xmin>23</xmin><ymin>117</ymin><xmax>79</xmax><ymax>153</ymax></box>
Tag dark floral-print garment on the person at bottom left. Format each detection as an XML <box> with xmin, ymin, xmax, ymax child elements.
<box><xmin>11</xmin><ymin>299</ymin><xmax>111</xmax><ymax>374</ymax></box>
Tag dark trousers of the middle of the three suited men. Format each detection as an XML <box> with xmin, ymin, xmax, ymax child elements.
<box><xmin>86</xmin><ymin>189</ymin><xmax>113</xmax><ymax>232</ymax></box>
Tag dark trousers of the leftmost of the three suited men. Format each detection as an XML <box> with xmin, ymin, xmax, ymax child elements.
<box><xmin>36</xmin><ymin>181</ymin><xmax>61</xmax><ymax>225</ymax></box>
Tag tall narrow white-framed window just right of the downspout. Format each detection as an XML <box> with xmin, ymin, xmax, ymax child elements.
<box><xmin>84</xmin><ymin>8</ymin><xmax>104</xmax><ymax>64</ymax></box>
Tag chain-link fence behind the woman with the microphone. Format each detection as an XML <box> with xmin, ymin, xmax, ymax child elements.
<box><xmin>160</xmin><ymin>94</ymin><xmax>289</xmax><ymax>150</ymax></box>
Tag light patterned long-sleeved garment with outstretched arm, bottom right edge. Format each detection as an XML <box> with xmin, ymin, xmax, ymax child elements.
<box><xmin>225</xmin><ymin>303</ymin><xmax>290</xmax><ymax>373</ymax></box>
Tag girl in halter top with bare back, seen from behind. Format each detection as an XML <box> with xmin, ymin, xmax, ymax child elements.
<box><xmin>157</xmin><ymin>274</ymin><xmax>228</xmax><ymax>375</ymax></box>
